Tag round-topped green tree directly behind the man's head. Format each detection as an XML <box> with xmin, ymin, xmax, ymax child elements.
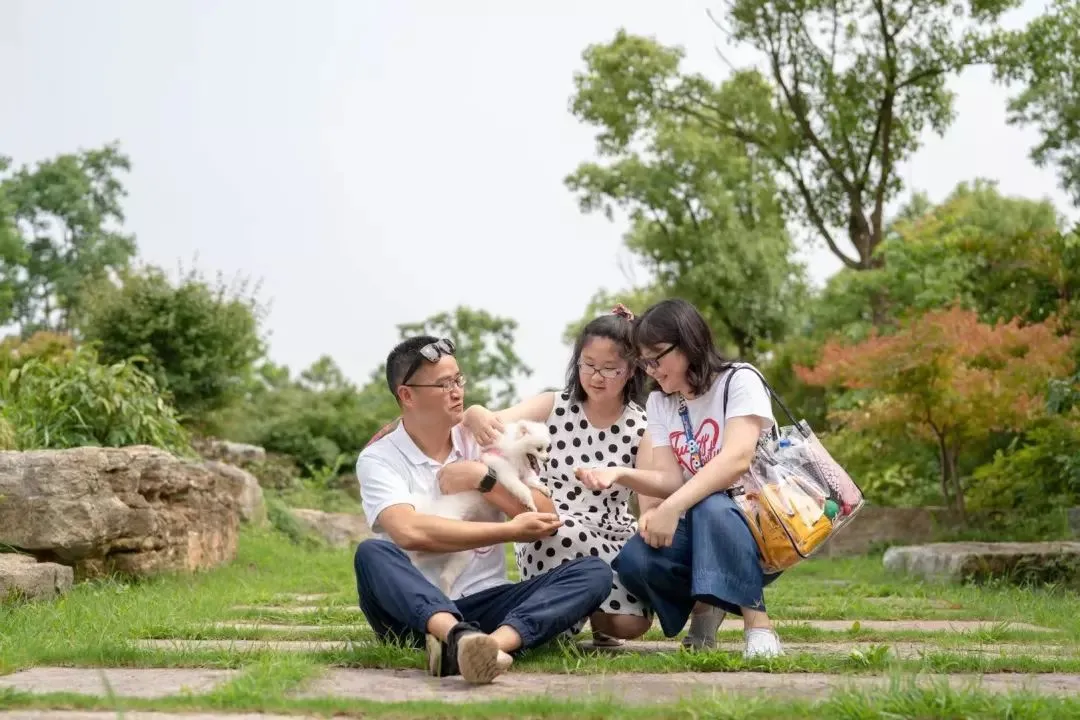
<box><xmin>397</xmin><ymin>307</ymin><xmax>532</xmax><ymax>407</ymax></box>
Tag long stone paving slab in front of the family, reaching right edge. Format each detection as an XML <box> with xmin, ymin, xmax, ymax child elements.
<box><xmin>296</xmin><ymin>669</ymin><xmax>1080</xmax><ymax>705</ymax></box>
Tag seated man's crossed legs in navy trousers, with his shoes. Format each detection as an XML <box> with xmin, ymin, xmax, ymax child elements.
<box><xmin>354</xmin><ymin>539</ymin><xmax>612</xmax><ymax>682</ymax></box>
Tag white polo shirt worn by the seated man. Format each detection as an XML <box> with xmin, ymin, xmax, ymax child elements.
<box><xmin>356</xmin><ymin>423</ymin><xmax>509</xmax><ymax>600</ymax></box>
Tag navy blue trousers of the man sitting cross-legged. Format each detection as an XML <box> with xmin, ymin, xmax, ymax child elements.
<box><xmin>353</xmin><ymin>539</ymin><xmax>613</xmax><ymax>650</ymax></box>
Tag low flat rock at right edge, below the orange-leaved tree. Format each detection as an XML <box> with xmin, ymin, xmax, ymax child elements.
<box><xmin>883</xmin><ymin>542</ymin><xmax>1080</xmax><ymax>584</ymax></box>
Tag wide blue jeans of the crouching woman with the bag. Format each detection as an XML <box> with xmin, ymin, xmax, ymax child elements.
<box><xmin>611</xmin><ymin>492</ymin><xmax>780</xmax><ymax>638</ymax></box>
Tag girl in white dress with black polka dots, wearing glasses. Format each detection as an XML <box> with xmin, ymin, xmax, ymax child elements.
<box><xmin>463</xmin><ymin>304</ymin><xmax>652</xmax><ymax>646</ymax></box>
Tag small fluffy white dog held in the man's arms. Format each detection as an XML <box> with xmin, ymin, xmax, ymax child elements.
<box><xmin>409</xmin><ymin>420</ymin><xmax>551</xmax><ymax>595</ymax></box>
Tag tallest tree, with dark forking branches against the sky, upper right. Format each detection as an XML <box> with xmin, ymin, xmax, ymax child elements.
<box><xmin>572</xmin><ymin>0</ymin><xmax>1018</xmax><ymax>270</ymax></box>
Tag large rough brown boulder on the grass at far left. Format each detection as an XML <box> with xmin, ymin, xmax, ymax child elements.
<box><xmin>0</xmin><ymin>446</ymin><xmax>244</xmax><ymax>579</ymax></box>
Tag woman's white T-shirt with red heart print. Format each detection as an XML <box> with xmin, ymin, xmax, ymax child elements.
<box><xmin>645</xmin><ymin>363</ymin><xmax>775</xmax><ymax>479</ymax></box>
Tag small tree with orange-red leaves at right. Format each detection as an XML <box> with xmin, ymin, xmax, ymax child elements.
<box><xmin>796</xmin><ymin>307</ymin><xmax>1074</xmax><ymax>517</ymax></box>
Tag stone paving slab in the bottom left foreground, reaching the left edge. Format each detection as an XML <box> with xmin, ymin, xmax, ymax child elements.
<box><xmin>0</xmin><ymin>667</ymin><xmax>238</xmax><ymax>697</ymax></box>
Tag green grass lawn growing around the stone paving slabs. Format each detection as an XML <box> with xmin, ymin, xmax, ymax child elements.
<box><xmin>0</xmin><ymin>529</ymin><xmax>1080</xmax><ymax>718</ymax></box>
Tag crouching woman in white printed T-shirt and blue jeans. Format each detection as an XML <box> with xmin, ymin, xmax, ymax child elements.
<box><xmin>579</xmin><ymin>299</ymin><xmax>783</xmax><ymax>658</ymax></box>
